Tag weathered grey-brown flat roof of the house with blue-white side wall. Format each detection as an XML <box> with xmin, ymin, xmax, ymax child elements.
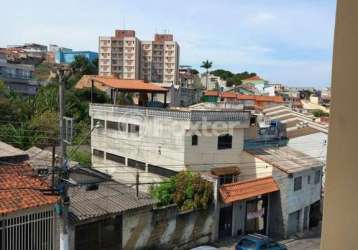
<box><xmin>245</xmin><ymin>146</ymin><xmax>323</xmax><ymax>174</ymax></box>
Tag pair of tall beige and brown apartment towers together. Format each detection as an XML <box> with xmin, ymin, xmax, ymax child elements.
<box><xmin>99</xmin><ymin>30</ymin><xmax>179</xmax><ymax>84</ymax></box>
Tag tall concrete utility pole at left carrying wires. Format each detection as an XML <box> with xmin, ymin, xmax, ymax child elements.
<box><xmin>57</xmin><ymin>65</ymin><xmax>70</xmax><ymax>250</ymax></box>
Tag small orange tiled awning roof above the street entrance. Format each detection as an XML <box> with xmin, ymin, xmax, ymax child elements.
<box><xmin>219</xmin><ymin>177</ymin><xmax>279</xmax><ymax>204</ymax></box>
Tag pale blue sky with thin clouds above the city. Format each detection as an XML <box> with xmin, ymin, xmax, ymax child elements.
<box><xmin>0</xmin><ymin>0</ymin><xmax>336</xmax><ymax>87</ymax></box>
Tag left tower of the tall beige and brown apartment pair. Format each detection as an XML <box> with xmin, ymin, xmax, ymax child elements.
<box><xmin>98</xmin><ymin>30</ymin><xmax>140</xmax><ymax>80</ymax></box>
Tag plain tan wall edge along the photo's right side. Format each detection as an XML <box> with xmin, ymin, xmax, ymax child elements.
<box><xmin>321</xmin><ymin>0</ymin><xmax>358</xmax><ymax>250</ymax></box>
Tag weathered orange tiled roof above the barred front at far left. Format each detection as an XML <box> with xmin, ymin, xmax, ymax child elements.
<box><xmin>0</xmin><ymin>165</ymin><xmax>58</xmax><ymax>215</ymax></box>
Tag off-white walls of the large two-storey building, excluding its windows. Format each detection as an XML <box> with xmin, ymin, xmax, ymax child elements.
<box><xmin>91</xmin><ymin>107</ymin><xmax>248</xmax><ymax>174</ymax></box>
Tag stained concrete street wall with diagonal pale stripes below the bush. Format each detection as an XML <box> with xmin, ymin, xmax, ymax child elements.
<box><xmin>123</xmin><ymin>207</ymin><xmax>214</xmax><ymax>250</ymax></box>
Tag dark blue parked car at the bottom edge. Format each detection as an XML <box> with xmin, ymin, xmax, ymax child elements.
<box><xmin>235</xmin><ymin>234</ymin><xmax>287</xmax><ymax>250</ymax></box>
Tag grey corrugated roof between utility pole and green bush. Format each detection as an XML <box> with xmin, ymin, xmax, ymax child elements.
<box><xmin>68</xmin><ymin>181</ymin><xmax>155</xmax><ymax>222</ymax></box>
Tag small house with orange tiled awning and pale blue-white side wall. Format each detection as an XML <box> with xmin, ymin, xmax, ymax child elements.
<box><xmin>210</xmin><ymin>147</ymin><xmax>322</xmax><ymax>239</ymax></box>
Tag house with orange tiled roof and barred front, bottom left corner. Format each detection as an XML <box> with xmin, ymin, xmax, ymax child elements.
<box><xmin>0</xmin><ymin>142</ymin><xmax>59</xmax><ymax>250</ymax></box>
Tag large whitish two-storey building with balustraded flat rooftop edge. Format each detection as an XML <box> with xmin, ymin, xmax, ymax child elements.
<box><xmin>90</xmin><ymin>104</ymin><xmax>250</xmax><ymax>179</ymax></box>
